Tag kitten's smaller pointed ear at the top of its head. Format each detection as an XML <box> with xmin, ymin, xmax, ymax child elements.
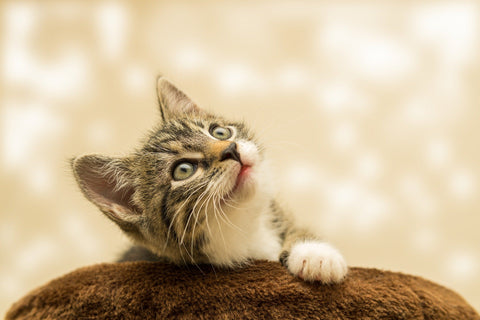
<box><xmin>157</xmin><ymin>76</ymin><xmax>202</xmax><ymax>121</ymax></box>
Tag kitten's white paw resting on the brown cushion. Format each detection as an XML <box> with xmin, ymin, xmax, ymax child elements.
<box><xmin>287</xmin><ymin>241</ymin><xmax>348</xmax><ymax>283</ymax></box>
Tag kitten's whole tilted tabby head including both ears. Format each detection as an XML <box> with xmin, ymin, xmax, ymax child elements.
<box><xmin>72</xmin><ymin>78</ymin><xmax>266</xmax><ymax>263</ymax></box>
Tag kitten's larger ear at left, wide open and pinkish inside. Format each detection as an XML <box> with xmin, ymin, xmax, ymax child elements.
<box><xmin>71</xmin><ymin>155</ymin><xmax>142</xmax><ymax>236</ymax></box>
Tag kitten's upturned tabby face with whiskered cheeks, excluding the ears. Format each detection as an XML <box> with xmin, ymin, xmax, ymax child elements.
<box><xmin>133</xmin><ymin>116</ymin><xmax>263</xmax><ymax>260</ymax></box>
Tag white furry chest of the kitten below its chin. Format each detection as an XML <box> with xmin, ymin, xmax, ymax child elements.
<box><xmin>204</xmin><ymin>208</ymin><xmax>281</xmax><ymax>266</ymax></box>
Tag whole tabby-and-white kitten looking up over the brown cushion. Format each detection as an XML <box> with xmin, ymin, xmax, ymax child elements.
<box><xmin>71</xmin><ymin>78</ymin><xmax>348</xmax><ymax>283</ymax></box>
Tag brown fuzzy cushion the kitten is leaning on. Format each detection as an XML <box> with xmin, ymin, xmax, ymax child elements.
<box><xmin>6</xmin><ymin>261</ymin><xmax>480</xmax><ymax>320</ymax></box>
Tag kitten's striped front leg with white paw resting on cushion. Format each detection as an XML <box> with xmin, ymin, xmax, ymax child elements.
<box><xmin>276</xmin><ymin>202</ymin><xmax>348</xmax><ymax>283</ymax></box>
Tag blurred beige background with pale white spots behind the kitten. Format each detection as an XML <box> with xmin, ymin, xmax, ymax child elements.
<box><xmin>0</xmin><ymin>0</ymin><xmax>480</xmax><ymax>314</ymax></box>
